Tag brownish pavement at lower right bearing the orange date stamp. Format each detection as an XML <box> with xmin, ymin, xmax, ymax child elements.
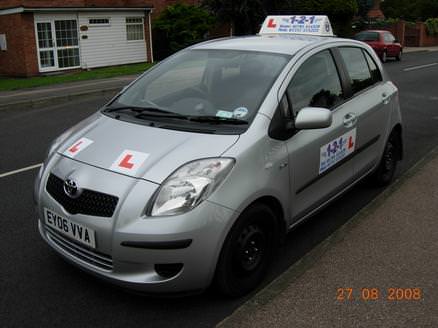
<box><xmin>218</xmin><ymin>148</ymin><xmax>438</xmax><ymax>328</ymax></box>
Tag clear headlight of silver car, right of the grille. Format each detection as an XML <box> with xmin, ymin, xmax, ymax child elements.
<box><xmin>148</xmin><ymin>158</ymin><xmax>234</xmax><ymax>216</ymax></box>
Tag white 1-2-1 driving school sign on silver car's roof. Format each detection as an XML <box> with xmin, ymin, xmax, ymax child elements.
<box><xmin>259</xmin><ymin>15</ymin><xmax>333</xmax><ymax>36</ymax></box>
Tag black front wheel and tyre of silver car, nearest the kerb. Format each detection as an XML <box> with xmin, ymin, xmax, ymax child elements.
<box><xmin>215</xmin><ymin>204</ymin><xmax>278</xmax><ymax>297</ymax></box>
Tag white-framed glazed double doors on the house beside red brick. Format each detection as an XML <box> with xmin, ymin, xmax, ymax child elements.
<box><xmin>35</xmin><ymin>18</ymin><xmax>80</xmax><ymax>72</ymax></box>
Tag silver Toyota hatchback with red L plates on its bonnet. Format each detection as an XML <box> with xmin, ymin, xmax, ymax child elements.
<box><xmin>35</xmin><ymin>16</ymin><xmax>402</xmax><ymax>296</ymax></box>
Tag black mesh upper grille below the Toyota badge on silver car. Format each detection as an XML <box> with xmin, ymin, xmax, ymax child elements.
<box><xmin>46</xmin><ymin>174</ymin><xmax>119</xmax><ymax>217</ymax></box>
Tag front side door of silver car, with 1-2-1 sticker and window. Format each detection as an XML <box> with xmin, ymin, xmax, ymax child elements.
<box><xmin>283</xmin><ymin>50</ymin><xmax>356</xmax><ymax>221</ymax></box>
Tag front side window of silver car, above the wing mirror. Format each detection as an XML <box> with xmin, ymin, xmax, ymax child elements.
<box><xmin>287</xmin><ymin>50</ymin><xmax>344</xmax><ymax>115</ymax></box>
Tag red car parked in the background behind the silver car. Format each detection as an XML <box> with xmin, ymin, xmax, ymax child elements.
<box><xmin>354</xmin><ymin>30</ymin><xmax>403</xmax><ymax>63</ymax></box>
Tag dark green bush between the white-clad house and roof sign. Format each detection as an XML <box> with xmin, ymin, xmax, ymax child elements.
<box><xmin>153</xmin><ymin>3</ymin><xmax>216</xmax><ymax>58</ymax></box>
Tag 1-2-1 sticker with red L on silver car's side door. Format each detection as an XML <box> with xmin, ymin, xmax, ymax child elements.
<box><xmin>319</xmin><ymin>129</ymin><xmax>356</xmax><ymax>174</ymax></box>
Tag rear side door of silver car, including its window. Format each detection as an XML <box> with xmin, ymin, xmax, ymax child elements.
<box><xmin>338</xmin><ymin>47</ymin><xmax>394</xmax><ymax>177</ymax></box>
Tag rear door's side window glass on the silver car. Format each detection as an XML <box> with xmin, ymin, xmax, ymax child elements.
<box><xmin>339</xmin><ymin>47</ymin><xmax>374</xmax><ymax>93</ymax></box>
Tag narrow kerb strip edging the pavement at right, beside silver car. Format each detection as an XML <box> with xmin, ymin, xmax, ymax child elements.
<box><xmin>216</xmin><ymin>146</ymin><xmax>438</xmax><ymax>328</ymax></box>
